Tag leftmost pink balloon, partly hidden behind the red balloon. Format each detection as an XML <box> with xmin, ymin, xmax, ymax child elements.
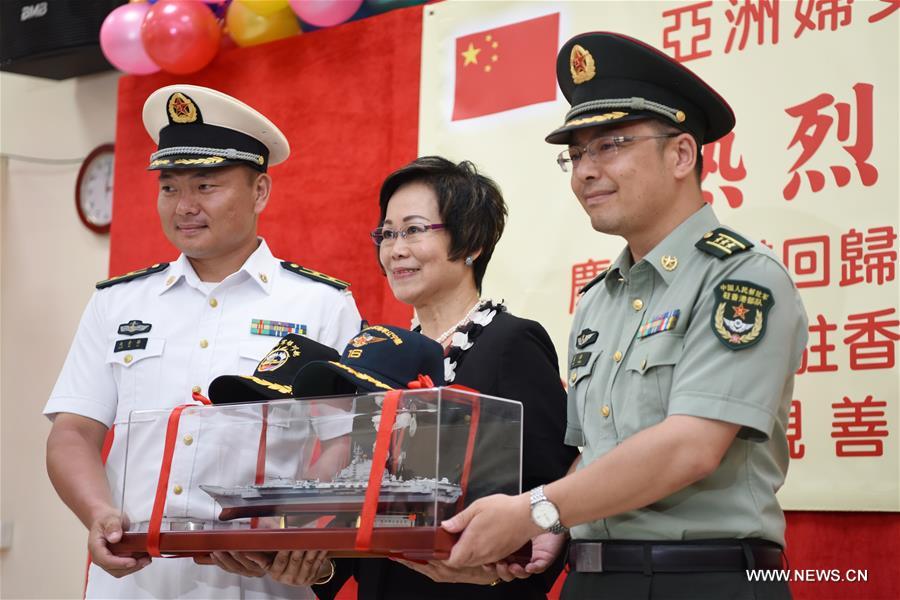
<box><xmin>100</xmin><ymin>2</ymin><xmax>159</xmax><ymax>75</ymax></box>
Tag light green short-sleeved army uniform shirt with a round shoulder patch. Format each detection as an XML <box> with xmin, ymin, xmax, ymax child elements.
<box><xmin>566</xmin><ymin>205</ymin><xmax>808</xmax><ymax>545</ymax></box>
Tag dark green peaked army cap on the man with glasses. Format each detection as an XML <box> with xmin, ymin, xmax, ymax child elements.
<box><xmin>546</xmin><ymin>32</ymin><xmax>734</xmax><ymax>145</ymax></box>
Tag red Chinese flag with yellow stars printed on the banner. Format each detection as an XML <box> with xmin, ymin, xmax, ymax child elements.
<box><xmin>453</xmin><ymin>13</ymin><xmax>559</xmax><ymax>121</ymax></box>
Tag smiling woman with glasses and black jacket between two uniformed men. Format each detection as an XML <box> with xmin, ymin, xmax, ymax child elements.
<box><xmin>270</xmin><ymin>157</ymin><xmax>576</xmax><ymax>600</ymax></box>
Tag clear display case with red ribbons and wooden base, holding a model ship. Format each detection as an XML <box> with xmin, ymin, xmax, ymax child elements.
<box><xmin>113</xmin><ymin>387</ymin><xmax>522</xmax><ymax>559</ymax></box>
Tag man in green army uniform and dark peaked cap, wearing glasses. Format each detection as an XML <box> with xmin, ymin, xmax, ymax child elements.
<box><xmin>444</xmin><ymin>33</ymin><xmax>807</xmax><ymax>599</ymax></box>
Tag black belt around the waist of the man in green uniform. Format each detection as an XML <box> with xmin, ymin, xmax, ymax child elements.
<box><xmin>569</xmin><ymin>539</ymin><xmax>783</xmax><ymax>575</ymax></box>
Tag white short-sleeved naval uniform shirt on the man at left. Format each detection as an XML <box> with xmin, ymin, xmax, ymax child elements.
<box><xmin>44</xmin><ymin>240</ymin><xmax>360</xmax><ymax>598</ymax></box>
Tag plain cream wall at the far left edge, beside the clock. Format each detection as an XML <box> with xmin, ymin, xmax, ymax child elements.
<box><xmin>0</xmin><ymin>72</ymin><xmax>119</xmax><ymax>598</ymax></box>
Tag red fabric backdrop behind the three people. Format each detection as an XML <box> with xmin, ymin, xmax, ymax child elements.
<box><xmin>110</xmin><ymin>6</ymin><xmax>900</xmax><ymax>600</ymax></box>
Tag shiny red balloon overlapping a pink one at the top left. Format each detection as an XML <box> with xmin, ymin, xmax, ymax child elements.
<box><xmin>141</xmin><ymin>0</ymin><xmax>222</xmax><ymax>75</ymax></box>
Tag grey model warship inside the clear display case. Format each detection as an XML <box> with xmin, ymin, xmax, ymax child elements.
<box><xmin>200</xmin><ymin>446</ymin><xmax>462</xmax><ymax>521</ymax></box>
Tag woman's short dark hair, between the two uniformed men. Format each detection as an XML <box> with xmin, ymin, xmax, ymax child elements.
<box><xmin>378</xmin><ymin>156</ymin><xmax>507</xmax><ymax>293</ymax></box>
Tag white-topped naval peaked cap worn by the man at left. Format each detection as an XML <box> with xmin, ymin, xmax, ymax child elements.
<box><xmin>143</xmin><ymin>84</ymin><xmax>291</xmax><ymax>173</ymax></box>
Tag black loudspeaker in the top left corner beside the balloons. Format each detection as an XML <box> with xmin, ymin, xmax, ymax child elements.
<box><xmin>0</xmin><ymin>0</ymin><xmax>128</xmax><ymax>79</ymax></box>
